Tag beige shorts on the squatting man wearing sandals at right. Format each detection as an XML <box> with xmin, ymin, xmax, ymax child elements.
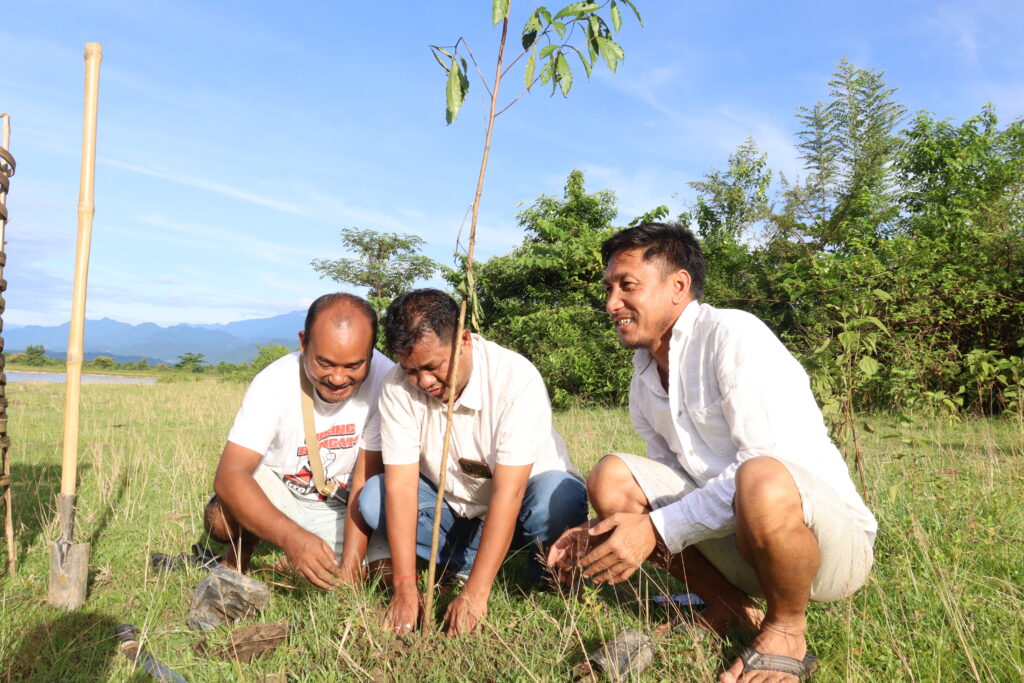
<box><xmin>610</xmin><ymin>453</ymin><xmax>874</xmax><ymax>602</ymax></box>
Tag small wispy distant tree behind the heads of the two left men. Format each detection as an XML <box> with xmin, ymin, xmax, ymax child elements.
<box><xmin>311</xmin><ymin>227</ymin><xmax>440</xmax><ymax>310</ymax></box>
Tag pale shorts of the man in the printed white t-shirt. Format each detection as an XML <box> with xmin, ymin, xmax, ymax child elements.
<box><xmin>253</xmin><ymin>465</ymin><xmax>391</xmax><ymax>562</ymax></box>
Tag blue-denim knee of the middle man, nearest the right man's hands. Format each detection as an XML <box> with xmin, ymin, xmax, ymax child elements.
<box><xmin>519</xmin><ymin>471</ymin><xmax>588</xmax><ymax>544</ymax></box>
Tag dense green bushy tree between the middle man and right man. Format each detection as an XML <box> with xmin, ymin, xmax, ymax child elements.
<box><xmin>446</xmin><ymin>171</ymin><xmax>632</xmax><ymax>408</ymax></box>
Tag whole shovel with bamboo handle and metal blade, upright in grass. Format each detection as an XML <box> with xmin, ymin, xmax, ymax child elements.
<box><xmin>50</xmin><ymin>43</ymin><xmax>103</xmax><ymax>610</ymax></box>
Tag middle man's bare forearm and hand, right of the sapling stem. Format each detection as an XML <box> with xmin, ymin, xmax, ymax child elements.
<box><xmin>444</xmin><ymin>465</ymin><xmax>534</xmax><ymax>635</ymax></box>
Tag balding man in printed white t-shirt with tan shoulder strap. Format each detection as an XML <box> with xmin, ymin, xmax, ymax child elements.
<box><xmin>204</xmin><ymin>293</ymin><xmax>394</xmax><ymax>589</ymax></box>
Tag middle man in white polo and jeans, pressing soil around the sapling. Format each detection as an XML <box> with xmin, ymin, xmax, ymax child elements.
<box><xmin>359</xmin><ymin>290</ymin><xmax>587</xmax><ymax>635</ymax></box>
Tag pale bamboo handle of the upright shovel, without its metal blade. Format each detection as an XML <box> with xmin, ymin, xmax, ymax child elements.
<box><xmin>60</xmin><ymin>43</ymin><xmax>103</xmax><ymax>496</ymax></box>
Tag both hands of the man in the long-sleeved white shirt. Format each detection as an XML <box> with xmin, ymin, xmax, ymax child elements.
<box><xmin>548</xmin><ymin>512</ymin><xmax>657</xmax><ymax>584</ymax></box>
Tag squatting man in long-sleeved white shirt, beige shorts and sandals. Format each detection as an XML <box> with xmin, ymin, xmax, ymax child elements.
<box><xmin>549</xmin><ymin>223</ymin><xmax>878</xmax><ymax>681</ymax></box>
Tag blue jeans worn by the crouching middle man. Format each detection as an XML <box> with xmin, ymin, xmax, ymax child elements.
<box><xmin>359</xmin><ymin>471</ymin><xmax>588</xmax><ymax>580</ymax></box>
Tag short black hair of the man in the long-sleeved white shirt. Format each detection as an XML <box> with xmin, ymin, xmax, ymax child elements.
<box><xmin>601</xmin><ymin>222</ymin><xmax>707</xmax><ymax>299</ymax></box>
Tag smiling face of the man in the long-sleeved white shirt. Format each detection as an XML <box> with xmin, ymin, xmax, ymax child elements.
<box><xmin>604</xmin><ymin>248</ymin><xmax>689</xmax><ymax>351</ymax></box>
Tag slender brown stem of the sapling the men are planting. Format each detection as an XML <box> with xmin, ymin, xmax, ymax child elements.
<box><xmin>424</xmin><ymin>2</ymin><xmax>512</xmax><ymax>625</ymax></box>
